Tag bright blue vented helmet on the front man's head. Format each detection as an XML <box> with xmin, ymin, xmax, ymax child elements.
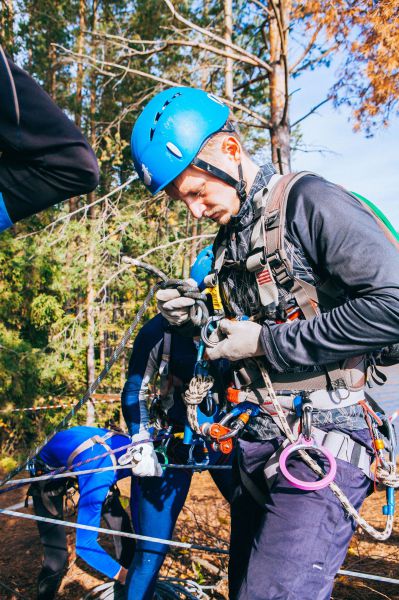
<box><xmin>131</xmin><ymin>87</ymin><xmax>246</xmax><ymax>200</ymax></box>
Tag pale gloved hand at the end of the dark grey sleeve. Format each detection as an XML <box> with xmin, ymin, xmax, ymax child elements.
<box><xmin>206</xmin><ymin>319</ymin><xmax>265</xmax><ymax>362</ymax></box>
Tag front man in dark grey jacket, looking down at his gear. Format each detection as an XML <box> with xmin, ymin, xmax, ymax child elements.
<box><xmin>132</xmin><ymin>88</ymin><xmax>399</xmax><ymax>600</ymax></box>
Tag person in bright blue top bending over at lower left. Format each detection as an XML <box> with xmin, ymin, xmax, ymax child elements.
<box><xmin>30</xmin><ymin>426</ymin><xmax>134</xmax><ymax>600</ymax></box>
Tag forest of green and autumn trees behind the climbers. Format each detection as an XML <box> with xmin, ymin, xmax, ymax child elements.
<box><xmin>0</xmin><ymin>0</ymin><xmax>399</xmax><ymax>468</ymax></box>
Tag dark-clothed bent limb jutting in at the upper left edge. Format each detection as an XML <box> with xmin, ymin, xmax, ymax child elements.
<box><xmin>0</xmin><ymin>46</ymin><xmax>99</xmax><ymax>229</ymax></box>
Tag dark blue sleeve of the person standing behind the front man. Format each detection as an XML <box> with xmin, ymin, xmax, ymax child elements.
<box><xmin>122</xmin><ymin>315</ymin><xmax>165</xmax><ymax>439</ymax></box>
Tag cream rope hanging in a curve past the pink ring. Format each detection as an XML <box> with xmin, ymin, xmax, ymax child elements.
<box><xmin>257</xmin><ymin>360</ymin><xmax>399</xmax><ymax>541</ymax></box>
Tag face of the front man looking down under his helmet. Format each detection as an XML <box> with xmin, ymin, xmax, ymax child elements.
<box><xmin>166</xmin><ymin>165</ymin><xmax>240</xmax><ymax>225</ymax></box>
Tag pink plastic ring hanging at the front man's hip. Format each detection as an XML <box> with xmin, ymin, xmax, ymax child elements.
<box><xmin>279</xmin><ymin>435</ymin><xmax>337</xmax><ymax>491</ymax></box>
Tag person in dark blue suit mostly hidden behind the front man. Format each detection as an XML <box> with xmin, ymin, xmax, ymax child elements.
<box><xmin>120</xmin><ymin>246</ymin><xmax>232</xmax><ymax>600</ymax></box>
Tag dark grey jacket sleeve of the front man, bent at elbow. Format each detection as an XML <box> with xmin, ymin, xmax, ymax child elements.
<box><xmin>262</xmin><ymin>176</ymin><xmax>399</xmax><ymax>372</ymax></box>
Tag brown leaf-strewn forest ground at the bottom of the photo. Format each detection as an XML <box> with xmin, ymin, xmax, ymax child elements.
<box><xmin>0</xmin><ymin>473</ymin><xmax>399</xmax><ymax>600</ymax></box>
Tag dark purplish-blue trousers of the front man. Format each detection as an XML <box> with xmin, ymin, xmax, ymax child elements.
<box><xmin>229</xmin><ymin>432</ymin><xmax>370</xmax><ymax>600</ymax></box>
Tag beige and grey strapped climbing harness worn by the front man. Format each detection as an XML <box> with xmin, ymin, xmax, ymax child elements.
<box><xmin>198</xmin><ymin>172</ymin><xmax>399</xmax><ymax>539</ymax></box>
